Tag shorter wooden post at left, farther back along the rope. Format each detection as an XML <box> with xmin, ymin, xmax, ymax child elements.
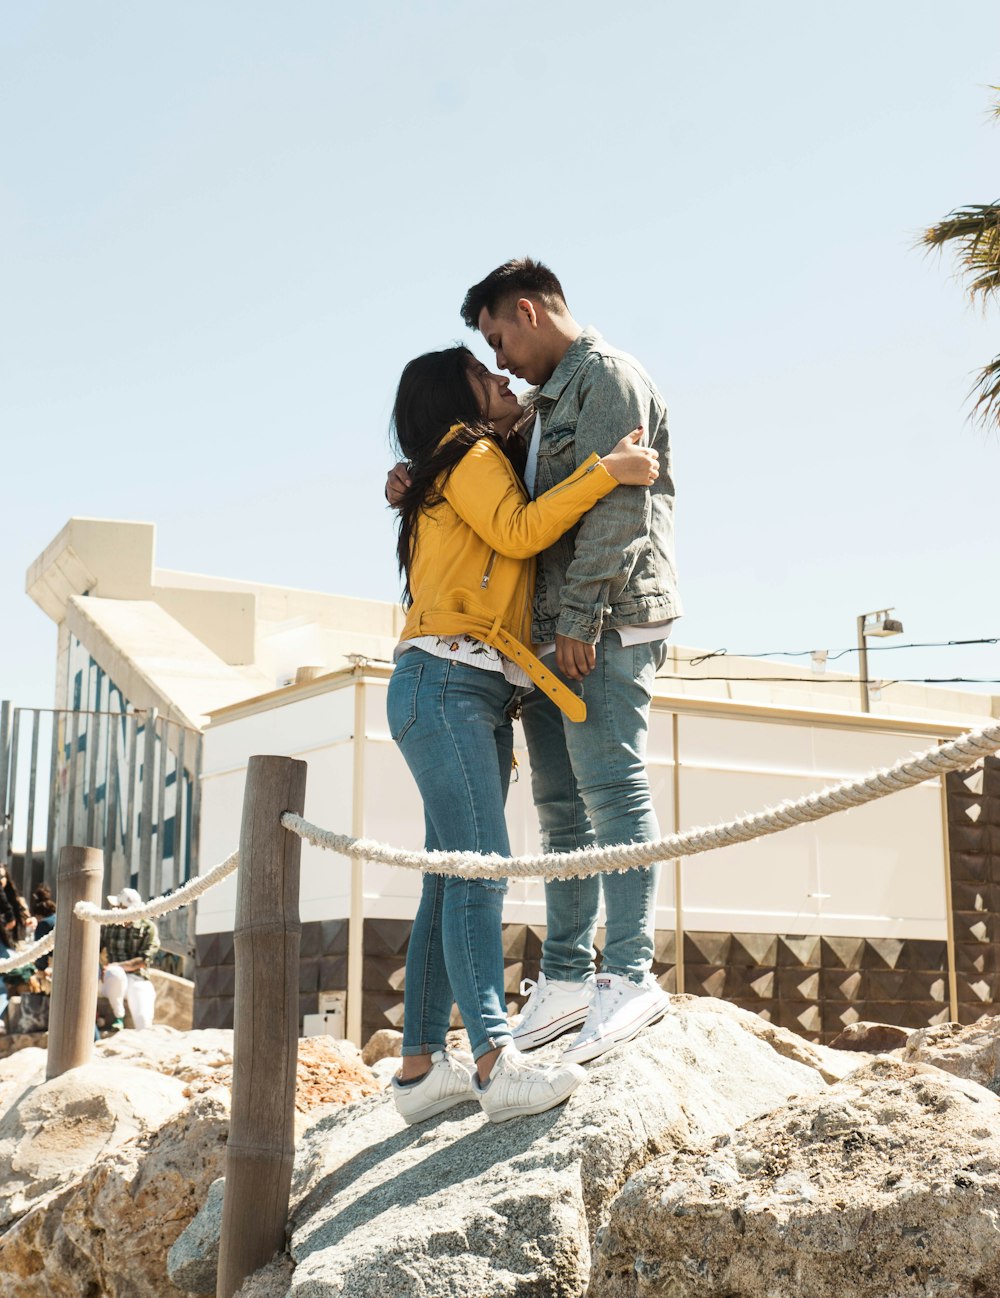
<box><xmin>45</xmin><ymin>848</ymin><xmax>104</xmax><ymax>1080</ymax></box>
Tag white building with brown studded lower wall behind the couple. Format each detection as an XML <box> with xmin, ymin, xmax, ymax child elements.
<box><xmin>9</xmin><ymin>519</ymin><xmax>1000</xmax><ymax>1036</ymax></box>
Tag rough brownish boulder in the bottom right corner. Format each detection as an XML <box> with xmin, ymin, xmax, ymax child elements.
<box><xmin>590</xmin><ymin>1058</ymin><xmax>1000</xmax><ymax>1298</ymax></box>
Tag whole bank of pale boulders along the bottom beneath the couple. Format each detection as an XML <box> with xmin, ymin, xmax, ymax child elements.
<box><xmin>0</xmin><ymin>997</ymin><xmax>1000</xmax><ymax>1298</ymax></box>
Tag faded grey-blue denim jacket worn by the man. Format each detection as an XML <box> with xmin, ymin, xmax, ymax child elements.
<box><xmin>530</xmin><ymin>328</ymin><xmax>683</xmax><ymax>644</ymax></box>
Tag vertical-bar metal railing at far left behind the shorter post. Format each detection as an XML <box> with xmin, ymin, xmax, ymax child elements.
<box><xmin>0</xmin><ymin>702</ymin><xmax>201</xmax><ymax>958</ymax></box>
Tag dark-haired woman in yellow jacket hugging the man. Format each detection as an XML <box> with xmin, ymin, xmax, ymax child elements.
<box><xmin>387</xmin><ymin>347</ymin><xmax>657</xmax><ymax>1123</ymax></box>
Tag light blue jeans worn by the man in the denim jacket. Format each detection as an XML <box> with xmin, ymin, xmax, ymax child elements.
<box><xmin>522</xmin><ymin>631</ymin><xmax>666</xmax><ymax>983</ymax></box>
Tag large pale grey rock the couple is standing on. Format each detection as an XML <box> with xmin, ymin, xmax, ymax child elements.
<box><xmin>231</xmin><ymin>998</ymin><xmax>826</xmax><ymax>1298</ymax></box>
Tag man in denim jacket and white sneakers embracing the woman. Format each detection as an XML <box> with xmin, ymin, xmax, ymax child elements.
<box><xmin>387</xmin><ymin>258</ymin><xmax>682</xmax><ymax>1063</ymax></box>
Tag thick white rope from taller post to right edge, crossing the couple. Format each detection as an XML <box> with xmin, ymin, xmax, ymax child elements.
<box><xmin>282</xmin><ymin>724</ymin><xmax>1000</xmax><ymax>879</ymax></box>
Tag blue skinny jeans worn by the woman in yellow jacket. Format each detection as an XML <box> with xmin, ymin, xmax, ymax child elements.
<box><xmin>386</xmin><ymin>649</ymin><xmax>522</xmax><ymax>1059</ymax></box>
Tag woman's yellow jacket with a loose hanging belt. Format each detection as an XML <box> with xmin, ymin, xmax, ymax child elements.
<box><xmin>403</xmin><ymin>437</ymin><xmax>618</xmax><ymax>720</ymax></box>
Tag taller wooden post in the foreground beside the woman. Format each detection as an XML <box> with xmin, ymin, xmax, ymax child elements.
<box><xmin>216</xmin><ymin>757</ymin><xmax>306</xmax><ymax>1298</ymax></box>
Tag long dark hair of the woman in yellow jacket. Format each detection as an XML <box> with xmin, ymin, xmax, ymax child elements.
<box><xmin>392</xmin><ymin>347</ymin><xmax>504</xmax><ymax>607</ymax></box>
